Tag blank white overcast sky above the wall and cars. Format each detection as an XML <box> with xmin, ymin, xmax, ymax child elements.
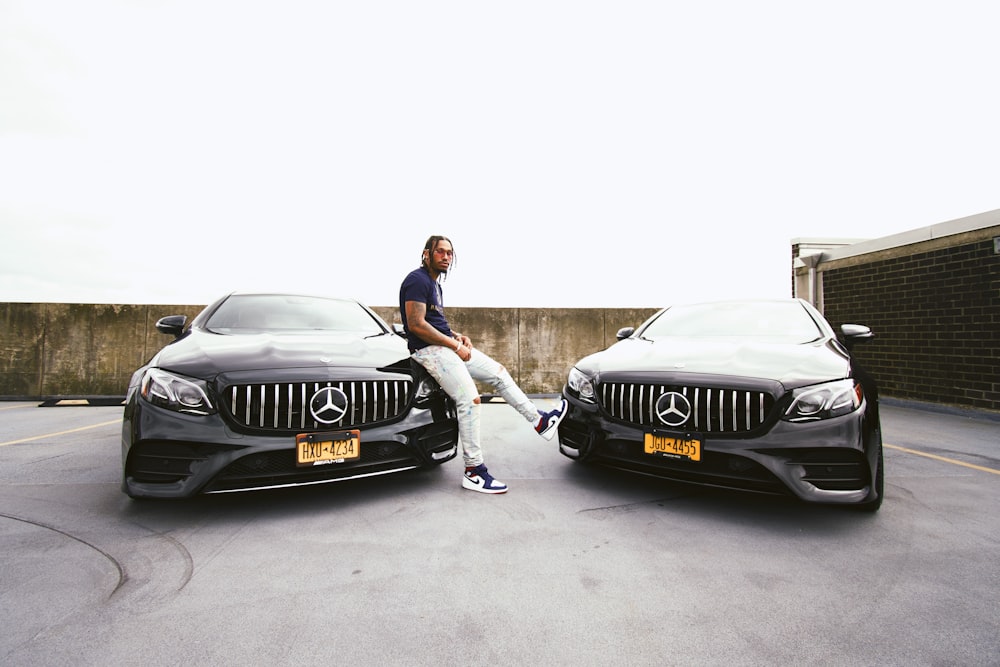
<box><xmin>0</xmin><ymin>0</ymin><xmax>1000</xmax><ymax>307</ymax></box>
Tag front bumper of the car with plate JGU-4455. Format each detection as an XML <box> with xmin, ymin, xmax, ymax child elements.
<box><xmin>559</xmin><ymin>393</ymin><xmax>880</xmax><ymax>504</ymax></box>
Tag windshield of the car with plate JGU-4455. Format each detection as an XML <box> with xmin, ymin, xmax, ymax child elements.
<box><xmin>639</xmin><ymin>301</ymin><xmax>823</xmax><ymax>343</ymax></box>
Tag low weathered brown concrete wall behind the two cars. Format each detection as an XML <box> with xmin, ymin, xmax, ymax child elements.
<box><xmin>0</xmin><ymin>303</ymin><xmax>656</xmax><ymax>399</ymax></box>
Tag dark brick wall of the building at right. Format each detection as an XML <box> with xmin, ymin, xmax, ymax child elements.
<box><xmin>819</xmin><ymin>227</ymin><xmax>1000</xmax><ymax>411</ymax></box>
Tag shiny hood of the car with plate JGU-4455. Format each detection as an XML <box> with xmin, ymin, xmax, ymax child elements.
<box><xmin>577</xmin><ymin>338</ymin><xmax>850</xmax><ymax>389</ymax></box>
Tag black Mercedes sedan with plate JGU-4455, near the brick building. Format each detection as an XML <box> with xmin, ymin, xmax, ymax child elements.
<box><xmin>559</xmin><ymin>299</ymin><xmax>884</xmax><ymax>511</ymax></box>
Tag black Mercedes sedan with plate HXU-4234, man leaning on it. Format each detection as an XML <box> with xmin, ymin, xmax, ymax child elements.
<box><xmin>122</xmin><ymin>294</ymin><xmax>458</xmax><ymax>498</ymax></box>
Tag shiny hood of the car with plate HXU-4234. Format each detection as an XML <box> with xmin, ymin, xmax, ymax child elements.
<box><xmin>149</xmin><ymin>330</ymin><xmax>409</xmax><ymax>379</ymax></box>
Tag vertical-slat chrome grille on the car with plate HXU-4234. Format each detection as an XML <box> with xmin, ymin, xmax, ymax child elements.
<box><xmin>224</xmin><ymin>380</ymin><xmax>412</xmax><ymax>432</ymax></box>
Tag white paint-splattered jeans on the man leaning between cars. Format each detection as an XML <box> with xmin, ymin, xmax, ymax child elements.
<box><xmin>413</xmin><ymin>345</ymin><xmax>538</xmax><ymax>467</ymax></box>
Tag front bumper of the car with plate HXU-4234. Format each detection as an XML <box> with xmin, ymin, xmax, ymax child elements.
<box><xmin>122</xmin><ymin>400</ymin><xmax>458</xmax><ymax>498</ymax></box>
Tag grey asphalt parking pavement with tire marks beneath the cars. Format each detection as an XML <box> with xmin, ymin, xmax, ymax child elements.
<box><xmin>0</xmin><ymin>397</ymin><xmax>1000</xmax><ymax>666</ymax></box>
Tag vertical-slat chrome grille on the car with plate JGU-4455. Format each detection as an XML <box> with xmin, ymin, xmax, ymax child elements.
<box><xmin>599</xmin><ymin>382</ymin><xmax>774</xmax><ymax>433</ymax></box>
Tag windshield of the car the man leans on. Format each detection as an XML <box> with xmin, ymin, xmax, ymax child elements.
<box><xmin>205</xmin><ymin>294</ymin><xmax>386</xmax><ymax>336</ymax></box>
